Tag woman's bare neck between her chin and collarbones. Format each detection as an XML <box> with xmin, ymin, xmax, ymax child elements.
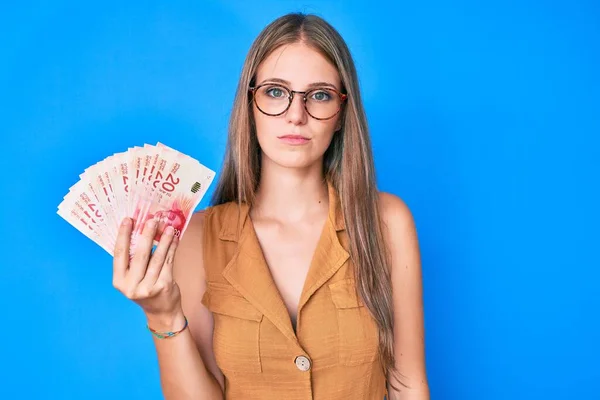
<box><xmin>252</xmin><ymin>157</ymin><xmax>329</xmax><ymax>223</ymax></box>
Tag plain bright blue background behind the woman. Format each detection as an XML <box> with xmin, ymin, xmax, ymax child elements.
<box><xmin>0</xmin><ymin>0</ymin><xmax>600</xmax><ymax>400</ymax></box>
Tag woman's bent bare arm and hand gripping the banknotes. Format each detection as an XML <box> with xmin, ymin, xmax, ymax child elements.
<box><xmin>113</xmin><ymin>213</ymin><xmax>224</xmax><ymax>400</ymax></box>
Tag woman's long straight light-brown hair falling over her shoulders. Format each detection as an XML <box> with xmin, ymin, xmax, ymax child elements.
<box><xmin>211</xmin><ymin>13</ymin><xmax>398</xmax><ymax>388</ymax></box>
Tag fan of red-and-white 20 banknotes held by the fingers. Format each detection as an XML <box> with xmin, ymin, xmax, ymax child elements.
<box><xmin>57</xmin><ymin>143</ymin><xmax>215</xmax><ymax>256</ymax></box>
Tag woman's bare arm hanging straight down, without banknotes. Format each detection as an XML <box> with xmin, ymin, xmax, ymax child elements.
<box><xmin>380</xmin><ymin>193</ymin><xmax>429</xmax><ymax>400</ymax></box>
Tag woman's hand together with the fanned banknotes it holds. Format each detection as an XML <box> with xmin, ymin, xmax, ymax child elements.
<box><xmin>57</xmin><ymin>143</ymin><xmax>215</xmax><ymax>328</ymax></box>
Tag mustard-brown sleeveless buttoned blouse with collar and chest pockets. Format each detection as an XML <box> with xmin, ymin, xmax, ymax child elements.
<box><xmin>202</xmin><ymin>185</ymin><xmax>386</xmax><ymax>400</ymax></box>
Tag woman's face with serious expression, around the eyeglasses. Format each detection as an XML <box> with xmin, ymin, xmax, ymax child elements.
<box><xmin>253</xmin><ymin>43</ymin><xmax>341</xmax><ymax>168</ymax></box>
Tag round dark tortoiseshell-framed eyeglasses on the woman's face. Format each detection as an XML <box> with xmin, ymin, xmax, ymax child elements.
<box><xmin>249</xmin><ymin>83</ymin><xmax>348</xmax><ymax>120</ymax></box>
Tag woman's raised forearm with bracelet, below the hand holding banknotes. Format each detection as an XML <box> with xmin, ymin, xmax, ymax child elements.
<box><xmin>148</xmin><ymin>317</ymin><xmax>223</xmax><ymax>400</ymax></box>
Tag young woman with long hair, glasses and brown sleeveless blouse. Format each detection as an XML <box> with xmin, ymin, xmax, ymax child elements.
<box><xmin>114</xmin><ymin>10</ymin><xmax>429</xmax><ymax>400</ymax></box>
